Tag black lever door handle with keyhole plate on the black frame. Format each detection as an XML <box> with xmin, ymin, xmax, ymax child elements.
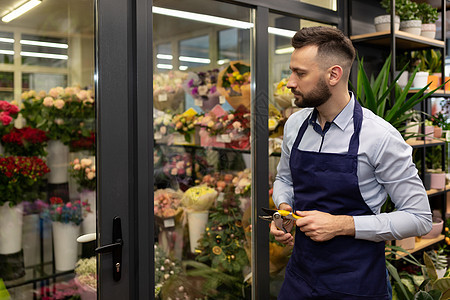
<box><xmin>95</xmin><ymin>216</ymin><xmax>123</xmax><ymax>281</ymax></box>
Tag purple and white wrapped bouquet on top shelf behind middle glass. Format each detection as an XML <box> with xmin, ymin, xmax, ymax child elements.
<box><xmin>184</xmin><ymin>69</ymin><xmax>220</xmax><ymax>112</ymax></box>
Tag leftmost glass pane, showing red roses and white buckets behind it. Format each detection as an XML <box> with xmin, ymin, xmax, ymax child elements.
<box><xmin>0</xmin><ymin>0</ymin><xmax>96</xmax><ymax>299</ymax></box>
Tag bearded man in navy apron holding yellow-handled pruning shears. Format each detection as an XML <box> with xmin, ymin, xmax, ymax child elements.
<box><xmin>271</xmin><ymin>27</ymin><xmax>432</xmax><ymax>300</ymax></box>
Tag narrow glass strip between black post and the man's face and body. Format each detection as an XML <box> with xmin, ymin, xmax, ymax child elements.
<box><xmin>269</xmin><ymin>14</ymin><xmax>327</xmax><ymax>297</ymax></box>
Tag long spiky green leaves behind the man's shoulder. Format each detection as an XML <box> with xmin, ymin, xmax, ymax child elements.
<box><xmin>350</xmin><ymin>55</ymin><xmax>444</xmax><ymax>139</ymax></box>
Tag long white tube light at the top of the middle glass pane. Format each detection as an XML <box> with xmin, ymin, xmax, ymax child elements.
<box><xmin>153</xmin><ymin>6</ymin><xmax>253</xmax><ymax>29</ymax></box>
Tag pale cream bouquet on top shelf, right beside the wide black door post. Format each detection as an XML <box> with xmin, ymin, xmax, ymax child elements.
<box><xmin>153</xmin><ymin>71</ymin><xmax>187</xmax><ymax>110</ymax></box>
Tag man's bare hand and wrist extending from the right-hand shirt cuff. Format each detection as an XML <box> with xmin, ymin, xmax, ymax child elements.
<box><xmin>296</xmin><ymin>210</ymin><xmax>355</xmax><ymax>242</ymax></box>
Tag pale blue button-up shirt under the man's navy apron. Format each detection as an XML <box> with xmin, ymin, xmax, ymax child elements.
<box><xmin>273</xmin><ymin>93</ymin><xmax>432</xmax><ymax>241</ymax></box>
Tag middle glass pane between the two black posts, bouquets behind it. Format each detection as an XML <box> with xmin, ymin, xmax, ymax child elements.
<box><xmin>153</xmin><ymin>0</ymin><xmax>253</xmax><ymax>299</ymax></box>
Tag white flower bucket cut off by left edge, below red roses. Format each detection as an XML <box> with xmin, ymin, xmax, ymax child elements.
<box><xmin>0</xmin><ymin>202</ymin><xmax>23</xmax><ymax>254</ymax></box>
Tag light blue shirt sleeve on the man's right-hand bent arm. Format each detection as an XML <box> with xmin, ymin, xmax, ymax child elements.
<box><xmin>353</xmin><ymin>130</ymin><xmax>432</xmax><ymax>241</ymax></box>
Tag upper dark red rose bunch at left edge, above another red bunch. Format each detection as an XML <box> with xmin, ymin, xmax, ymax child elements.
<box><xmin>2</xmin><ymin>127</ymin><xmax>48</xmax><ymax>156</ymax></box>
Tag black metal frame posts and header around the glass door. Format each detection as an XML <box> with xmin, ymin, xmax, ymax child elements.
<box><xmin>95</xmin><ymin>0</ymin><xmax>340</xmax><ymax>299</ymax></box>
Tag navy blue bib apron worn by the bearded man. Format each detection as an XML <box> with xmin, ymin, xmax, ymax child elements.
<box><xmin>278</xmin><ymin>101</ymin><xmax>390</xmax><ymax>300</ymax></box>
